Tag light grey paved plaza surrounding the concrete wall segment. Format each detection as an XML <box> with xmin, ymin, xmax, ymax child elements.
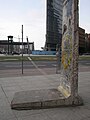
<box><xmin>0</xmin><ymin>72</ymin><xmax>90</xmax><ymax>120</ymax></box>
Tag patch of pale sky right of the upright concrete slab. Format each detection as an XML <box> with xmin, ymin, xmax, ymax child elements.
<box><xmin>79</xmin><ymin>0</ymin><xmax>90</xmax><ymax>33</ymax></box>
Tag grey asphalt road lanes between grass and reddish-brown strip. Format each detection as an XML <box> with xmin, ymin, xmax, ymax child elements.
<box><xmin>0</xmin><ymin>60</ymin><xmax>90</xmax><ymax>70</ymax></box>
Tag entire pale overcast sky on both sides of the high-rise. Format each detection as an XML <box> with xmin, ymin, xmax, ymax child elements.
<box><xmin>0</xmin><ymin>0</ymin><xmax>90</xmax><ymax>49</ymax></box>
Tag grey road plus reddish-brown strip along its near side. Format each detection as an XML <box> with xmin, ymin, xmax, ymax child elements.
<box><xmin>0</xmin><ymin>60</ymin><xmax>90</xmax><ymax>77</ymax></box>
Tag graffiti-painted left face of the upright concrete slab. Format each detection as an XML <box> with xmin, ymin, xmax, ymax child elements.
<box><xmin>61</xmin><ymin>0</ymin><xmax>72</xmax><ymax>93</ymax></box>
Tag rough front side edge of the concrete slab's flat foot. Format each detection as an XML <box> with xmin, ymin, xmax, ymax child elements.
<box><xmin>11</xmin><ymin>96</ymin><xmax>83</xmax><ymax>110</ymax></box>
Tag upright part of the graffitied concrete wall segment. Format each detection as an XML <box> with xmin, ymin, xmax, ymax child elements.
<box><xmin>58</xmin><ymin>0</ymin><xmax>79</xmax><ymax>101</ymax></box>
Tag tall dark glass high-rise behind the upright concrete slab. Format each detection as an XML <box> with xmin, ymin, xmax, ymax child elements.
<box><xmin>45</xmin><ymin>0</ymin><xmax>63</xmax><ymax>51</ymax></box>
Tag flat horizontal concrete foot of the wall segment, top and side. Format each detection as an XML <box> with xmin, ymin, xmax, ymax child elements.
<box><xmin>11</xmin><ymin>89</ymin><xmax>83</xmax><ymax>110</ymax></box>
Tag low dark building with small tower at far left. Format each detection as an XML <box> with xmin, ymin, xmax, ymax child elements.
<box><xmin>0</xmin><ymin>36</ymin><xmax>34</xmax><ymax>54</ymax></box>
